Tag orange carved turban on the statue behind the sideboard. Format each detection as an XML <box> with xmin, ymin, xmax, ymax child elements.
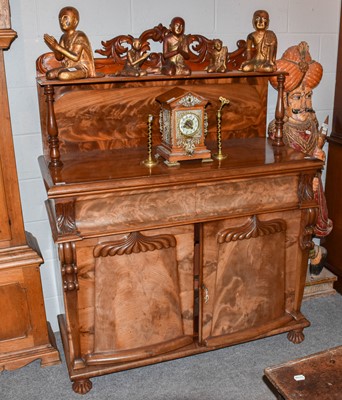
<box><xmin>270</xmin><ymin>42</ymin><xmax>323</xmax><ymax>92</ymax></box>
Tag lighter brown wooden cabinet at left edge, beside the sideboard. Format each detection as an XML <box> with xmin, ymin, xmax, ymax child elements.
<box><xmin>0</xmin><ymin>1</ymin><xmax>60</xmax><ymax>371</ymax></box>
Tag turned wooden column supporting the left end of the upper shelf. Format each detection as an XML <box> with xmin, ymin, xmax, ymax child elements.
<box><xmin>44</xmin><ymin>85</ymin><xmax>63</xmax><ymax>168</ymax></box>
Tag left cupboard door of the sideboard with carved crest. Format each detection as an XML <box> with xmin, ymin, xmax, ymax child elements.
<box><xmin>73</xmin><ymin>225</ymin><xmax>194</xmax><ymax>365</ymax></box>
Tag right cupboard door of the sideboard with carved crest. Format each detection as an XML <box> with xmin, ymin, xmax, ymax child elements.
<box><xmin>201</xmin><ymin>215</ymin><xmax>288</xmax><ymax>346</ymax></box>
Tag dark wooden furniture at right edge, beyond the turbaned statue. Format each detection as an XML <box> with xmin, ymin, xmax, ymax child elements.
<box><xmin>324</xmin><ymin>5</ymin><xmax>342</xmax><ymax>291</ymax></box>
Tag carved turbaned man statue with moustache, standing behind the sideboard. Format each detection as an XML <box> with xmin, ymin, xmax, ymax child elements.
<box><xmin>268</xmin><ymin>42</ymin><xmax>333</xmax><ymax>275</ymax></box>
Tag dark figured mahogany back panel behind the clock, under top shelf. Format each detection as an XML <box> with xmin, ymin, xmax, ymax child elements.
<box><xmin>38</xmin><ymin>74</ymin><xmax>268</xmax><ymax>155</ymax></box>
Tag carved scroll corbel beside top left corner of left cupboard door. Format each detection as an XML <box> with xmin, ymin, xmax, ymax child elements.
<box><xmin>58</xmin><ymin>242</ymin><xmax>78</xmax><ymax>292</ymax></box>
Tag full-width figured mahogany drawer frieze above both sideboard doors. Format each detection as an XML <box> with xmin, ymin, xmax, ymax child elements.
<box><xmin>75</xmin><ymin>175</ymin><xmax>298</xmax><ymax>235</ymax></box>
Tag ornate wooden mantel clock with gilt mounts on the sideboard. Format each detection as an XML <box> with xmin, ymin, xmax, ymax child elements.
<box><xmin>156</xmin><ymin>87</ymin><xmax>212</xmax><ymax>165</ymax></box>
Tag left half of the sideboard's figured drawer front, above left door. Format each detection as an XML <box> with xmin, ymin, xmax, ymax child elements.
<box><xmin>76</xmin><ymin>185</ymin><xmax>196</xmax><ymax>234</ymax></box>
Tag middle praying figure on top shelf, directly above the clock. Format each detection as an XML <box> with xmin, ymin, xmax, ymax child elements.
<box><xmin>161</xmin><ymin>17</ymin><xmax>191</xmax><ymax>75</ymax></box>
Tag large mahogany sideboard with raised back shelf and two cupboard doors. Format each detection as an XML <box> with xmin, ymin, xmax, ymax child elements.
<box><xmin>37</xmin><ymin>32</ymin><xmax>322</xmax><ymax>393</ymax></box>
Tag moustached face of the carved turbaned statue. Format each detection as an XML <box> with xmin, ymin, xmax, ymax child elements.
<box><xmin>285</xmin><ymin>86</ymin><xmax>313</xmax><ymax>123</ymax></box>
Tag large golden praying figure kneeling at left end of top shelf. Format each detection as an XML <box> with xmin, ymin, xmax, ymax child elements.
<box><xmin>44</xmin><ymin>7</ymin><xmax>96</xmax><ymax>81</ymax></box>
